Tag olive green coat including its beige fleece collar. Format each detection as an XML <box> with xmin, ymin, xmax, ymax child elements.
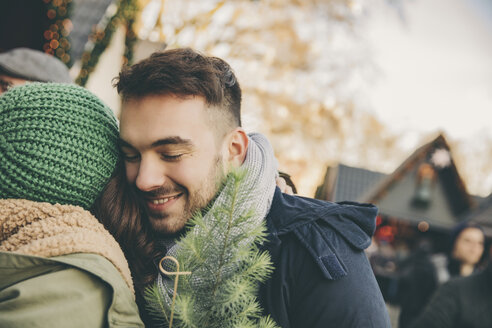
<box><xmin>0</xmin><ymin>200</ymin><xmax>143</xmax><ymax>328</ymax></box>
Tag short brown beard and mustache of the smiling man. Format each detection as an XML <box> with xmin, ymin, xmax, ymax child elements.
<box><xmin>137</xmin><ymin>156</ymin><xmax>224</xmax><ymax>235</ymax></box>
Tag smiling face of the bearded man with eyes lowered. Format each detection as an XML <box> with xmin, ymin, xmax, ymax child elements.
<box><xmin>120</xmin><ymin>95</ymin><xmax>227</xmax><ymax>234</ymax></box>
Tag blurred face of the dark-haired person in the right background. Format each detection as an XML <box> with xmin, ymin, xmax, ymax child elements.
<box><xmin>453</xmin><ymin>228</ymin><xmax>484</xmax><ymax>265</ymax></box>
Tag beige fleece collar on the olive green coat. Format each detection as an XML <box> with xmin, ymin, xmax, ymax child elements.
<box><xmin>0</xmin><ymin>199</ymin><xmax>133</xmax><ymax>291</ymax></box>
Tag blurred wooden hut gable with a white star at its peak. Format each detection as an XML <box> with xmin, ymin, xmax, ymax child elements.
<box><xmin>361</xmin><ymin>135</ymin><xmax>473</xmax><ymax>228</ymax></box>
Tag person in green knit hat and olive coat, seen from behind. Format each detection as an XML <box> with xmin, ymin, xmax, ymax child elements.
<box><xmin>0</xmin><ymin>83</ymin><xmax>143</xmax><ymax>328</ymax></box>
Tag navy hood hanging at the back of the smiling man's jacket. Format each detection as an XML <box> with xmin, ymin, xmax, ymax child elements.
<box><xmin>267</xmin><ymin>188</ymin><xmax>378</xmax><ymax>250</ymax></box>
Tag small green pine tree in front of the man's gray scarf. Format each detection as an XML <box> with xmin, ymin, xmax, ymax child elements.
<box><xmin>145</xmin><ymin>170</ymin><xmax>277</xmax><ymax>328</ymax></box>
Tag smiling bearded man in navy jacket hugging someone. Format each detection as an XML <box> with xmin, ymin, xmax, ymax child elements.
<box><xmin>116</xmin><ymin>49</ymin><xmax>390</xmax><ymax>328</ymax></box>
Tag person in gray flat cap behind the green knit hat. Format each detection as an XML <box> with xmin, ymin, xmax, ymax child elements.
<box><xmin>0</xmin><ymin>48</ymin><xmax>73</xmax><ymax>94</ymax></box>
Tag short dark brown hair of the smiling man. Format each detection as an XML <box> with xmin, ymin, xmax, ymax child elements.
<box><xmin>114</xmin><ymin>48</ymin><xmax>241</xmax><ymax>132</ymax></box>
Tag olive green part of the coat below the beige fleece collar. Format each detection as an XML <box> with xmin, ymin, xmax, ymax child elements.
<box><xmin>0</xmin><ymin>252</ymin><xmax>143</xmax><ymax>328</ymax></box>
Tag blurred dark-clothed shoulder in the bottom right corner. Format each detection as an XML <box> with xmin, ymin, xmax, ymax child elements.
<box><xmin>410</xmin><ymin>242</ymin><xmax>492</xmax><ymax>328</ymax></box>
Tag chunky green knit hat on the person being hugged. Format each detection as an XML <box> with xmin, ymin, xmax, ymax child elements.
<box><xmin>0</xmin><ymin>83</ymin><xmax>118</xmax><ymax>209</ymax></box>
